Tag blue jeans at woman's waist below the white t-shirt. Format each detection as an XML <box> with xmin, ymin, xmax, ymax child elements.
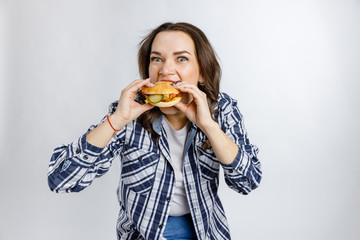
<box><xmin>163</xmin><ymin>214</ymin><xmax>196</xmax><ymax>240</ymax></box>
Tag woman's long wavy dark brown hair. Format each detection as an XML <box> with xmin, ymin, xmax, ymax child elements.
<box><xmin>138</xmin><ymin>22</ymin><xmax>221</xmax><ymax>143</ymax></box>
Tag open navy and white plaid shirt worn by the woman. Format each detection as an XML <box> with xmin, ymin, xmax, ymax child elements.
<box><xmin>48</xmin><ymin>93</ymin><xmax>261</xmax><ymax>239</ymax></box>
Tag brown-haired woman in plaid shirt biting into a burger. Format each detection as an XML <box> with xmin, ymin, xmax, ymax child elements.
<box><xmin>48</xmin><ymin>23</ymin><xmax>261</xmax><ymax>239</ymax></box>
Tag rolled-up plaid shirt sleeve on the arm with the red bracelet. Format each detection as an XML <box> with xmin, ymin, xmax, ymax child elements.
<box><xmin>48</xmin><ymin>101</ymin><xmax>125</xmax><ymax>192</ymax></box>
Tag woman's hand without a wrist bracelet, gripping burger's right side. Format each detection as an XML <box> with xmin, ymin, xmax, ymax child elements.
<box><xmin>175</xmin><ymin>82</ymin><xmax>214</xmax><ymax>131</ymax></box>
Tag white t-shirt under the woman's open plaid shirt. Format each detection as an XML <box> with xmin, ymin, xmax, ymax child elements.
<box><xmin>162</xmin><ymin>117</ymin><xmax>190</xmax><ymax>216</ymax></box>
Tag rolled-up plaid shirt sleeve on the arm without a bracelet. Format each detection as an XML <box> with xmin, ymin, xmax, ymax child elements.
<box><xmin>219</xmin><ymin>93</ymin><xmax>262</xmax><ymax>194</ymax></box>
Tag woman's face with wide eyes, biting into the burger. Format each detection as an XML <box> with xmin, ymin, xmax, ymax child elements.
<box><xmin>149</xmin><ymin>31</ymin><xmax>202</xmax><ymax>114</ymax></box>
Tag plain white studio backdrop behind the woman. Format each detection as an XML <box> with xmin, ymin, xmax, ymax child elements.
<box><xmin>0</xmin><ymin>0</ymin><xmax>360</xmax><ymax>240</ymax></box>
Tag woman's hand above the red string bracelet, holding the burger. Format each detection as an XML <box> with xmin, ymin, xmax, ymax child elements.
<box><xmin>110</xmin><ymin>78</ymin><xmax>154</xmax><ymax>129</ymax></box>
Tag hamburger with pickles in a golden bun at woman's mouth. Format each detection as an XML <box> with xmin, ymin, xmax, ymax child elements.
<box><xmin>141</xmin><ymin>81</ymin><xmax>182</xmax><ymax>107</ymax></box>
